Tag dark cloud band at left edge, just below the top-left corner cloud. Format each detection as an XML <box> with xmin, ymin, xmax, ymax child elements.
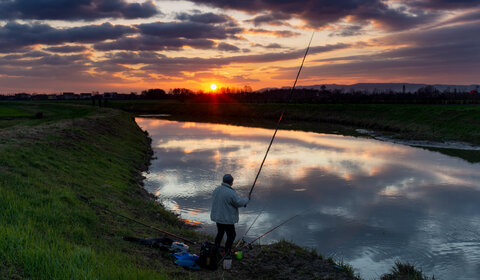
<box><xmin>0</xmin><ymin>22</ymin><xmax>135</xmax><ymax>52</ymax></box>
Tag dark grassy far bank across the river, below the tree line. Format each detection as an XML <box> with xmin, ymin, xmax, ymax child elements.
<box><xmin>109</xmin><ymin>100</ymin><xmax>480</xmax><ymax>144</ymax></box>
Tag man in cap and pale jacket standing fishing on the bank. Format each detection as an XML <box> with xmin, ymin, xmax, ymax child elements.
<box><xmin>210</xmin><ymin>174</ymin><xmax>251</xmax><ymax>256</ymax></box>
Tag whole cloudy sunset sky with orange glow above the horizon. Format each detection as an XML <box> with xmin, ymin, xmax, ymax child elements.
<box><xmin>0</xmin><ymin>0</ymin><xmax>480</xmax><ymax>93</ymax></box>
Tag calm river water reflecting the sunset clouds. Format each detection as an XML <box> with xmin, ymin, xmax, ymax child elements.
<box><xmin>137</xmin><ymin>118</ymin><xmax>480</xmax><ymax>279</ymax></box>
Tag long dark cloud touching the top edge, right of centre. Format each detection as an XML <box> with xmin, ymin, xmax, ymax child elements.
<box><xmin>192</xmin><ymin>0</ymin><xmax>432</xmax><ymax>30</ymax></box>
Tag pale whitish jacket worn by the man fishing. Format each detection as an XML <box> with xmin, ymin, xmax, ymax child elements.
<box><xmin>210</xmin><ymin>183</ymin><xmax>248</xmax><ymax>225</ymax></box>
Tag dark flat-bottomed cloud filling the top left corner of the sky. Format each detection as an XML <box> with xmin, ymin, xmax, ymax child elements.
<box><xmin>0</xmin><ymin>0</ymin><xmax>158</xmax><ymax>20</ymax></box>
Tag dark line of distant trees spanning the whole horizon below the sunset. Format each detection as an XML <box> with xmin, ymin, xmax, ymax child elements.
<box><xmin>0</xmin><ymin>86</ymin><xmax>480</xmax><ymax>104</ymax></box>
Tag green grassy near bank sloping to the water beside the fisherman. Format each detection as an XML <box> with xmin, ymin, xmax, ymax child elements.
<box><xmin>0</xmin><ymin>102</ymin><xmax>436</xmax><ymax>279</ymax></box>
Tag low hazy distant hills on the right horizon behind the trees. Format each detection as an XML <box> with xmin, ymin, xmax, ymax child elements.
<box><xmin>259</xmin><ymin>83</ymin><xmax>479</xmax><ymax>92</ymax></box>
